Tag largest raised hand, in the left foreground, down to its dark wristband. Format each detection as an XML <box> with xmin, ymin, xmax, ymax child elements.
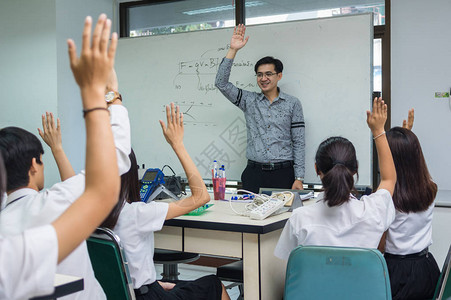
<box><xmin>67</xmin><ymin>14</ymin><xmax>117</xmax><ymax>108</ymax></box>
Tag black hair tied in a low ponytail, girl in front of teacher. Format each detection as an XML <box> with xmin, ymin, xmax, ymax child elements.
<box><xmin>315</xmin><ymin>136</ymin><xmax>359</xmax><ymax>207</ymax></box>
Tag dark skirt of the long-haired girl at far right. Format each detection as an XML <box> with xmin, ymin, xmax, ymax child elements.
<box><xmin>385</xmin><ymin>253</ymin><xmax>440</xmax><ymax>300</ymax></box>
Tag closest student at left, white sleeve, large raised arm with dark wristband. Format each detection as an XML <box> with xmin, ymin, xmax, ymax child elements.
<box><xmin>0</xmin><ymin>14</ymin><xmax>119</xmax><ymax>299</ymax></box>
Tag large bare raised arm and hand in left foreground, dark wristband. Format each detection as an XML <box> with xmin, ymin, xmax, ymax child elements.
<box><xmin>52</xmin><ymin>14</ymin><xmax>120</xmax><ymax>261</ymax></box>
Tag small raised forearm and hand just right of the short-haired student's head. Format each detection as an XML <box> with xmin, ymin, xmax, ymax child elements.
<box><xmin>38</xmin><ymin>112</ymin><xmax>75</xmax><ymax>181</ymax></box>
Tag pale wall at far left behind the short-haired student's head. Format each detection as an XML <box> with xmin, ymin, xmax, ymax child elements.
<box><xmin>0</xmin><ymin>0</ymin><xmax>59</xmax><ymax>184</ymax></box>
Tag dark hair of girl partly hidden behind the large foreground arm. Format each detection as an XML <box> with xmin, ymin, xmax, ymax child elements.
<box><xmin>100</xmin><ymin>149</ymin><xmax>141</xmax><ymax>229</ymax></box>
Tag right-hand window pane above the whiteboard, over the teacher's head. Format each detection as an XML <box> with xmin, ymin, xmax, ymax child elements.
<box><xmin>246</xmin><ymin>0</ymin><xmax>385</xmax><ymax>25</ymax></box>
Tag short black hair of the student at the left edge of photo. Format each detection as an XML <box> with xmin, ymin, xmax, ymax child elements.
<box><xmin>0</xmin><ymin>127</ymin><xmax>44</xmax><ymax>191</ymax></box>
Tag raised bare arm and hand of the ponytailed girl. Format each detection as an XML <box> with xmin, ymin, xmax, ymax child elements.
<box><xmin>366</xmin><ymin>98</ymin><xmax>396</xmax><ymax>196</ymax></box>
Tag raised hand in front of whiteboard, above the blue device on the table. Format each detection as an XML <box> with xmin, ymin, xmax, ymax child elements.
<box><xmin>160</xmin><ymin>103</ymin><xmax>184</xmax><ymax>148</ymax></box>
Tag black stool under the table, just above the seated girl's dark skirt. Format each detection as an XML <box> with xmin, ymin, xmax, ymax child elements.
<box><xmin>153</xmin><ymin>249</ymin><xmax>200</xmax><ymax>281</ymax></box>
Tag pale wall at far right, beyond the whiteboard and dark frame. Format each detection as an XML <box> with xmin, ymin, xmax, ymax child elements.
<box><xmin>391</xmin><ymin>0</ymin><xmax>451</xmax><ymax>268</ymax></box>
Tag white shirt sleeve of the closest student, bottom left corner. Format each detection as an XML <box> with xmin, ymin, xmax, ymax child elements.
<box><xmin>0</xmin><ymin>225</ymin><xmax>58</xmax><ymax>299</ymax></box>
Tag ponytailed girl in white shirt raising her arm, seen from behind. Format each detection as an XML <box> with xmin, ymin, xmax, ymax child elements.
<box><xmin>274</xmin><ymin>98</ymin><xmax>396</xmax><ymax>259</ymax></box>
